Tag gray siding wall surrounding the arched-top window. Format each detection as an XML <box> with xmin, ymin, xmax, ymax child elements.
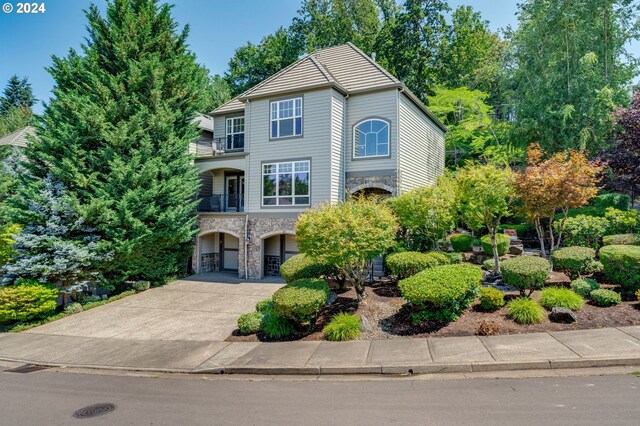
<box><xmin>345</xmin><ymin>89</ymin><xmax>398</xmax><ymax>172</ymax></box>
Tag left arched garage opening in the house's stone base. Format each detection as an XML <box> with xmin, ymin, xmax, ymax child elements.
<box><xmin>198</xmin><ymin>232</ymin><xmax>240</xmax><ymax>274</ymax></box>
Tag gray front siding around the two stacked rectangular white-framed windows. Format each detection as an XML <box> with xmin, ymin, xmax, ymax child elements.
<box><xmin>245</xmin><ymin>89</ymin><xmax>332</xmax><ymax>213</ymax></box>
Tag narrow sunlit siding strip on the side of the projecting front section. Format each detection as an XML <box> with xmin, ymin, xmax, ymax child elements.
<box><xmin>331</xmin><ymin>90</ymin><xmax>345</xmax><ymax>203</ymax></box>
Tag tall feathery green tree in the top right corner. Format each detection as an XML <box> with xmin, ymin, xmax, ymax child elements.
<box><xmin>510</xmin><ymin>0</ymin><xmax>640</xmax><ymax>151</ymax></box>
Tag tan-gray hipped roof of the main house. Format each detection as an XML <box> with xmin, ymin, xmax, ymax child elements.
<box><xmin>210</xmin><ymin>43</ymin><xmax>447</xmax><ymax>131</ymax></box>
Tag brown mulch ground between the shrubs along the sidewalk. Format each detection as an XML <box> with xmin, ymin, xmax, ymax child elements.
<box><xmin>226</xmin><ymin>273</ymin><xmax>640</xmax><ymax>342</ymax></box>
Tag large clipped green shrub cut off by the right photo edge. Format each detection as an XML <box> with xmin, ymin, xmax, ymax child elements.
<box><xmin>600</xmin><ymin>246</ymin><xmax>640</xmax><ymax>295</ymax></box>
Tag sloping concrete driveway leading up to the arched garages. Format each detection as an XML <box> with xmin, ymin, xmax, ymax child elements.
<box><xmin>26</xmin><ymin>273</ymin><xmax>283</xmax><ymax>341</ymax></box>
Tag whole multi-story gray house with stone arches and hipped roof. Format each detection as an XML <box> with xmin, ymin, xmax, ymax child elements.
<box><xmin>193</xmin><ymin>43</ymin><xmax>446</xmax><ymax>279</ymax></box>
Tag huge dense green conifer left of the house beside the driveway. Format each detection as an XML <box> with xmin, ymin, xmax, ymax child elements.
<box><xmin>10</xmin><ymin>0</ymin><xmax>207</xmax><ymax>283</ymax></box>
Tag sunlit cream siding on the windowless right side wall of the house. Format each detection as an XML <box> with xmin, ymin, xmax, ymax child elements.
<box><xmin>399</xmin><ymin>94</ymin><xmax>444</xmax><ymax>192</ymax></box>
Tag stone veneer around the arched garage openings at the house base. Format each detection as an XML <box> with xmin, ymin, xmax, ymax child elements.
<box><xmin>193</xmin><ymin>215</ymin><xmax>297</xmax><ymax>279</ymax></box>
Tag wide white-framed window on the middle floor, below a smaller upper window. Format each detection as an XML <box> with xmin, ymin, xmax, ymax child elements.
<box><xmin>262</xmin><ymin>161</ymin><xmax>311</xmax><ymax>206</ymax></box>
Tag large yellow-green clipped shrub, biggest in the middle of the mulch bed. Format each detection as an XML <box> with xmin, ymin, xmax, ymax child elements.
<box><xmin>398</xmin><ymin>265</ymin><xmax>482</xmax><ymax>321</ymax></box>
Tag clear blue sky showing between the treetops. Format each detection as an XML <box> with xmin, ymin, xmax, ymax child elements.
<box><xmin>0</xmin><ymin>0</ymin><xmax>640</xmax><ymax>112</ymax></box>
